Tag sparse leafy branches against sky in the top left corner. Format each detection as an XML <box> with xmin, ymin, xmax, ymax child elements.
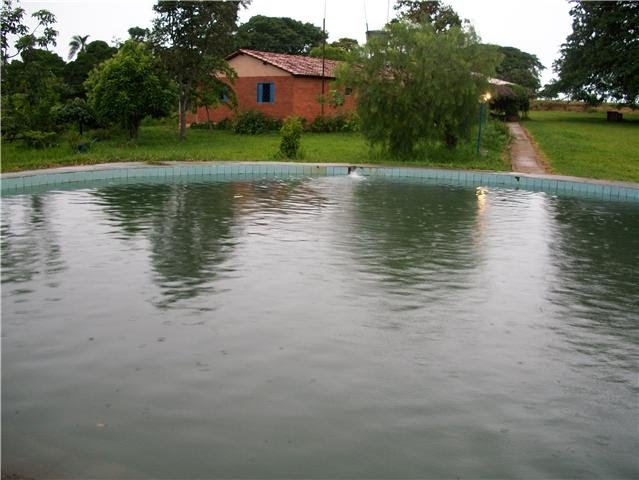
<box><xmin>0</xmin><ymin>0</ymin><xmax>58</xmax><ymax>65</ymax></box>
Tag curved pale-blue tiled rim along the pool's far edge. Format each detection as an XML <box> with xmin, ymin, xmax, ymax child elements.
<box><xmin>0</xmin><ymin>162</ymin><xmax>639</xmax><ymax>202</ymax></box>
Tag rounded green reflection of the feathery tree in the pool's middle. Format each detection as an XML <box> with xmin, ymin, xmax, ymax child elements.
<box><xmin>352</xmin><ymin>182</ymin><xmax>478</xmax><ymax>288</ymax></box>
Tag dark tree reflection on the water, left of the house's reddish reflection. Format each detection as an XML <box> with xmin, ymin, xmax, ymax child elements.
<box><xmin>94</xmin><ymin>183</ymin><xmax>234</xmax><ymax>306</ymax></box>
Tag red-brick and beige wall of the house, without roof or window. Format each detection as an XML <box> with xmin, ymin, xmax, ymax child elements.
<box><xmin>187</xmin><ymin>55</ymin><xmax>355</xmax><ymax>124</ymax></box>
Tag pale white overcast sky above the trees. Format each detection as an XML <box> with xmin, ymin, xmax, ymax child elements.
<box><xmin>21</xmin><ymin>0</ymin><xmax>572</xmax><ymax>83</ymax></box>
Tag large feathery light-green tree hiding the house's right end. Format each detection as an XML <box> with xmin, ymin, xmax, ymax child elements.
<box><xmin>339</xmin><ymin>22</ymin><xmax>498</xmax><ymax>157</ymax></box>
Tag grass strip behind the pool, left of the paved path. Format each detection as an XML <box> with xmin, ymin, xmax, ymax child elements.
<box><xmin>1</xmin><ymin>121</ymin><xmax>509</xmax><ymax>172</ymax></box>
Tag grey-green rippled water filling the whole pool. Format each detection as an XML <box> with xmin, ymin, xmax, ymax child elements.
<box><xmin>1</xmin><ymin>177</ymin><xmax>639</xmax><ymax>478</ymax></box>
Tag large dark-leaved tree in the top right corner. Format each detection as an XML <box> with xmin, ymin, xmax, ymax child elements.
<box><xmin>545</xmin><ymin>1</ymin><xmax>639</xmax><ymax>106</ymax></box>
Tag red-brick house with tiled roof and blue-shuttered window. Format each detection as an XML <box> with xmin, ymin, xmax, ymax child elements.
<box><xmin>187</xmin><ymin>49</ymin><xmax>355</xmax><ymax>124</ymax></box>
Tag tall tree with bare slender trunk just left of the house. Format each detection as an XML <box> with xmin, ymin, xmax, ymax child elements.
<box><xmin>151</xmin><ymin>0</ymin><xmax>248</xmax><ymax>140</ymax></box>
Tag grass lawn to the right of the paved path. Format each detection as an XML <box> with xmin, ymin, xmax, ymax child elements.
<box><xmin>522</xmin><ymin>111</ymin><xmax>639</xmax><ymax>182</ymax></box>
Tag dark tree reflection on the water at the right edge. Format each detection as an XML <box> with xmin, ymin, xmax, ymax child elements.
<box><xmin>550</xmin><ymin>198</ymin><xmax>639</xmax><ymax>387</ymax></box>
